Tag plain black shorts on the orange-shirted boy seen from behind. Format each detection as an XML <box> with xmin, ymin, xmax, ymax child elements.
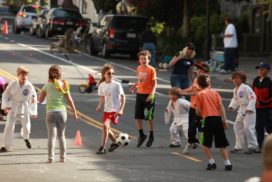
<box><xmin>202</xmin><ymin>116</ymin><xmax>229</xmax><ymax>148</ymax></box>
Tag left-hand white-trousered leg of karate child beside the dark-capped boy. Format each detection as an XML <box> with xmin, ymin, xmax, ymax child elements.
<box><xmin>233</xmin><ymin>114</ymin><xmax>245</xmax><ymax>152</ymax></box>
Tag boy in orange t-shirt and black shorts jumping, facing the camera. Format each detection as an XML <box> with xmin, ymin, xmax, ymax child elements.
<box><xmin>130</xmin><ymin>50</ymin><xmax>157</xmax><ymax>147</ymax></box>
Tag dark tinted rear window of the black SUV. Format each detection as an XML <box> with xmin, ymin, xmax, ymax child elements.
<box><xmin>115</xmin><ymin>17</ymin><xmax>146</xmax><ymax>31</ymax></box>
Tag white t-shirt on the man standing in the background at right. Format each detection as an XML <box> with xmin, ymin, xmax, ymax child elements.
<box><xmin>224</xmin><ymin>23</ymin><xmax>238</xmax><ymax>48</ymax></box>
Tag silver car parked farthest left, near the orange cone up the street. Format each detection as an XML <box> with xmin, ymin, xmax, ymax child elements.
<box><xmin>13</xmin><ymin>5</ymin><xmax>44</xmax><ymax>33</ymax></box>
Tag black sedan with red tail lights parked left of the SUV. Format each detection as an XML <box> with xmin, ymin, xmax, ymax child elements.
<box><xmin>44</xmin><ymin>8</ymin><xmax>87</xmax><ymax>38</ymax></box>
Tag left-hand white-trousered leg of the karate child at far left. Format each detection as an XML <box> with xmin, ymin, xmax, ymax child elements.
<box><xmin>2</xmin><ymin>112</ymin><xmax>16</xmax><ymax>149</ymax></box>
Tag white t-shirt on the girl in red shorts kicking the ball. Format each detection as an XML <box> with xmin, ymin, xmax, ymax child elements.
<box><xmin>98</xmin><ymin>80</ymin><xmax>124</xmax><ymax>112</ymax></box>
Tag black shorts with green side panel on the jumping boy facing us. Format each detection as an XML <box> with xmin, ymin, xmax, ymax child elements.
<box><xmin>135</xmin><ymin>93</ymin><xmax>155</xmax><ymax>121</ymax></box>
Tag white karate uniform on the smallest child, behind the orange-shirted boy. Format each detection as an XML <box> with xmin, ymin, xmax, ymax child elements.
<box><xmin>164</xmin><ymin>98</ymin><xmax>191</xmax><ymax>145</ymax></box>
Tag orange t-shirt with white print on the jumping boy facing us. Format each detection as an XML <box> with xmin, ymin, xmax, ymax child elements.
<box><xmin>137</xmin><ymin>65</ymin><xmax>157</xmax><ymax>94</ymax></box>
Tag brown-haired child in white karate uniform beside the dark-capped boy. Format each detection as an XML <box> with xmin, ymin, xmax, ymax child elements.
<box><xmin>228</xmin><ymin>71</ymin><xmax>258</xmax><ymax>154</ymax></box>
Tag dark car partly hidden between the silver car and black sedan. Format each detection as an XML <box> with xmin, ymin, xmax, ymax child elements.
<box><xmin>29</xmin><ymin>9</ymin><xmax>49</xmax><ymax>37</ymax></box>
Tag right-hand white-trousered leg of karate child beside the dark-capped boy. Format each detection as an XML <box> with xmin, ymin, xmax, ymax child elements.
<box><xmin>243</xmin><ymin>113</ymin><xmax>258</xmax><ymax>149</ymax></box>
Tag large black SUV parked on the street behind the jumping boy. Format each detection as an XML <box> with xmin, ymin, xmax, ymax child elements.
<box><xmin>90</xmin><ymin>15</ymin><xmax>147</xmax><ymax>58</ymax></box>
